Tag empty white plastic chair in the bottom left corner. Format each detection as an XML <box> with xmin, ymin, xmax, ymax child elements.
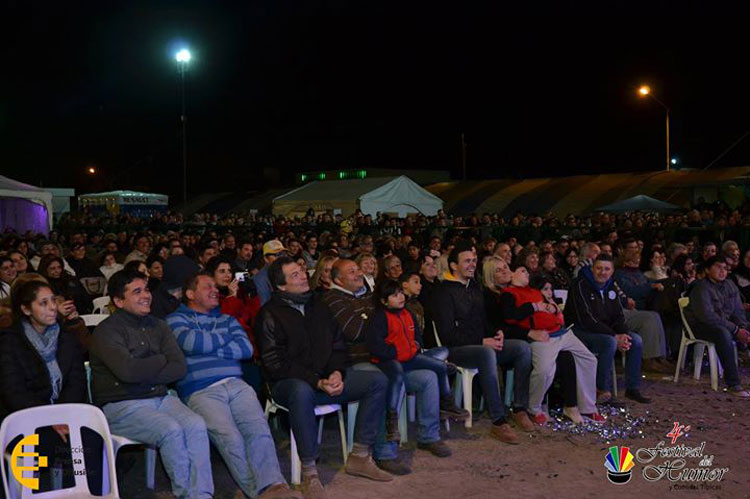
<box><xmin>0</xmin><ymin>404</ymin><xmax>120</xmax><ymax>499</ymax></box>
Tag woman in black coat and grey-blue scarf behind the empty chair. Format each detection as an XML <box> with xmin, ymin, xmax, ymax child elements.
<box><xmin>0</xmin><ymin>280</ymin><xmax>101</xmax><ymax>491</ymax></box>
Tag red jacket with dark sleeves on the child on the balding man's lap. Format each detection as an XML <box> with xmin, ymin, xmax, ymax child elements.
<box><xmin>366</xmin><ymin>308</ymin><xmax>422</xmax><ymax>363</ymax></box>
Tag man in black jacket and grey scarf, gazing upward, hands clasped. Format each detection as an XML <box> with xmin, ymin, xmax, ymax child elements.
<box><xmin>256</xmin><ymin>256</ymin><xmax>393</xmax><ymax>498</ymax></box>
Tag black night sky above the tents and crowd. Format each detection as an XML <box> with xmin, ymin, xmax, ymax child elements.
<box><xmin>0</xmin><ymin>0</ymin><xmax>750</xmax><ymax>199</ymax></box>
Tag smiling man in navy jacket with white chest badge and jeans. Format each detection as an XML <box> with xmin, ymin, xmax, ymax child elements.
<box><xmin>565</xmin><ymin>254</ymin><xmax>651</xmax><ymax>403</ymax></box>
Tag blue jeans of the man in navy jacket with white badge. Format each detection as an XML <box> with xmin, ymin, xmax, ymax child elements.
<box><xmin>573</xmin><ymin>326</ymin><xmax>643</xmax><ymax>391</ymax></box>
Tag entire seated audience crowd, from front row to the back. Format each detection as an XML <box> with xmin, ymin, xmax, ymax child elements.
<box><xmin>0</xmin><ymin>207</ymin><xmax>750</xmax><ymax>498</ymax></box>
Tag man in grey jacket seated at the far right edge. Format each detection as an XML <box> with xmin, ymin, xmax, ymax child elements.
<box><xmin>685</xmin><ymin>256</ymin><xmax>750</xmax><ymax>398</ymax></box>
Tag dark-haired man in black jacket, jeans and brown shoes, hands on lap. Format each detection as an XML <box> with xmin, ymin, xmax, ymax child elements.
<box><xmin>435</xmin><ymin>242</ymin><xmax>534</xmax><ymax>444</ymax></box>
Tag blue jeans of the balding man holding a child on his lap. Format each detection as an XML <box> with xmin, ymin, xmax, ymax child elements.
<box><xmin>352</xmin><ymin>363</ymin><xmax>440</xmax><ymax>461</ymax></box>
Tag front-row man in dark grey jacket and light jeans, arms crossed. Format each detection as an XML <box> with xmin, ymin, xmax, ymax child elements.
<box><xmin>90</xmin><ymin>270</ymin><xmax>213</xmax><ymax>498</ymax></box>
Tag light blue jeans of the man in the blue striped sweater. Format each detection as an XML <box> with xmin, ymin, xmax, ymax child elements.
<box><xmin>187</xmin><ymin>378</ymin><xmax>286</xmax><ymax>497</ymax></box>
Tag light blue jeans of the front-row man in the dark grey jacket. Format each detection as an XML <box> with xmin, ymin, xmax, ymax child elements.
<box><xmin>102</xmin><ymin>395</ymin><xmax>214</xmax><ymax>498</ymax></box>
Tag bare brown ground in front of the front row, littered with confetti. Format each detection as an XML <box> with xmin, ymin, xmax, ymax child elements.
<box><xmin>119</xmin><ymin>367</ymin><xmax>750</xmax><ymax>499</ymax></box>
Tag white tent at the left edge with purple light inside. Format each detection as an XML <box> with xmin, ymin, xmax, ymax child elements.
<box><xmin>0</xmin><ymin>175</ymin><xmax>53</xmax><ymax>234</ymax></box>
